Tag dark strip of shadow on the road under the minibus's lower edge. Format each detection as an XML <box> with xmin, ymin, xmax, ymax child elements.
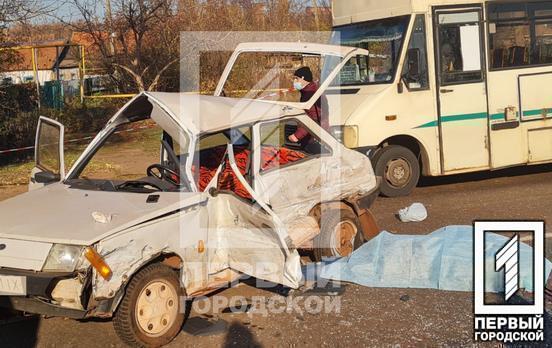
<box><xmin>419</xmin><ymin>164</ymin><xmax>552</xmax><ymax>187</ymax></box>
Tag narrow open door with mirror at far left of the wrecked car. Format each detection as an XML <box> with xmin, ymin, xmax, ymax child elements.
<box><xmin>29</xmin><ymin>116</ymin><xmax>65</xmax><ymax>191</ymax></box>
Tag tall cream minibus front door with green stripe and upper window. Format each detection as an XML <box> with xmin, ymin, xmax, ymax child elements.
<box><xmin>433</xmin><ymin>6</ymin><xmax>489</xmax><ymax>174</ymax></box>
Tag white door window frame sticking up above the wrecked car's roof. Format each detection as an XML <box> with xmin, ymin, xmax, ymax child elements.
<box><xmin>215</xmin><ymin>42</ymin><xmax>369</xmax><ymax>110</ymax></box>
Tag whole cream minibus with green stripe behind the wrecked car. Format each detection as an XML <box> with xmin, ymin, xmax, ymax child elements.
<box><xmin>327</xmin><ymin>0</ymin><xmax>552</xmax><ymax>196</ymax></box>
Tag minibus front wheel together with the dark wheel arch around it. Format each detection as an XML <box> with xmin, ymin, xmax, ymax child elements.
<box><xmin>372</xmin><ymin>135</ymin><xmax>429</xmax><ymax>197</ymax></box>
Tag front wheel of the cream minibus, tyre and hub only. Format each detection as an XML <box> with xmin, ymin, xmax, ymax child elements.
<box><xmin>372</xmin><ymin>145</ymin><xmax>420</xmax><ymax>197</ymax></box>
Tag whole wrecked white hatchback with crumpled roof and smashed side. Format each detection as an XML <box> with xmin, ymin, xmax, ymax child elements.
<box><xmin>0</xmin><ymin>43</ymin><xmax>378</xmax><ymax>346</ymax></box>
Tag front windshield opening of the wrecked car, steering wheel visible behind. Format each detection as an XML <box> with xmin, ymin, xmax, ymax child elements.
<box><xmin>69</xmin><ymin>119</ymin><xmax>189</xmax><ymax>192</ymax></box>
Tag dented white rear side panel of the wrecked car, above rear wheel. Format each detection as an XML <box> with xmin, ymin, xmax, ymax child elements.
<box><xmin>254</xmin><ymin>116</ymin><xmax>379</xmax><ymax>224</ymax></box>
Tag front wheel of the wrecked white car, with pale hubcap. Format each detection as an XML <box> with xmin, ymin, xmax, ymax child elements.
<box><xmin>113</xmin><ymin>263</ymin><xmax>185</xmax><ymax>347</ymax></box>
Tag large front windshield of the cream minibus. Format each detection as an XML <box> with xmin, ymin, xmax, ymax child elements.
<box><xmin>332</xmin><ymin>16</ymin><xmax>410</xmax><ymax>86</ymax></box>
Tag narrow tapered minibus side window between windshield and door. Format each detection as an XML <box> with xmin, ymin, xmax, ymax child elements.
<box><xmin>402</xmin><ymin>14</ymin><xmax>429</xmax><ymax>91</ymax></box>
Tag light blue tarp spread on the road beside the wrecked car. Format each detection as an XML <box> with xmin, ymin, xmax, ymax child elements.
<box><xmin>320</xmin><ymin>226</ymin><xmax>552</xmax><ymax>292</ymax></box>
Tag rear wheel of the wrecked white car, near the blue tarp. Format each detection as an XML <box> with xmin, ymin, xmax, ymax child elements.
<box><xmin>313</xmin><ymin>209</ymin><xmax>366</xmax><ymax>262</ymax></box>
